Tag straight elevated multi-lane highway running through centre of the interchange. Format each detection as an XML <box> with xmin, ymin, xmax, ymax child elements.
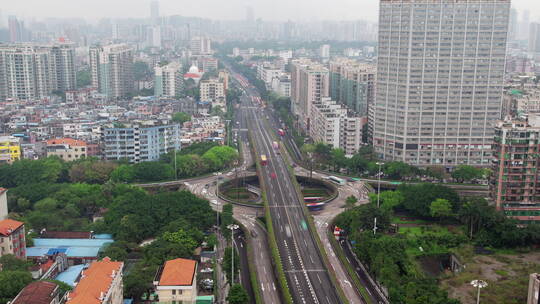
<box><xmin>233</xmin><ymin>76</ymin><xmax>341</xmax><ymax>304</ymax></box>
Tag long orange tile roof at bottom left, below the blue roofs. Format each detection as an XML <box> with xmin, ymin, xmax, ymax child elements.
<box><xmin>66</xmin><ymin>257</ymin><xmax>124</xmax><ymax>304</ymax></box>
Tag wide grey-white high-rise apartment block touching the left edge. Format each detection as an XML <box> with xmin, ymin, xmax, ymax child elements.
<box><xmin>0</xmin><ymin>43</ymin><xmax>76</xmax><ymax>100</ymax></box>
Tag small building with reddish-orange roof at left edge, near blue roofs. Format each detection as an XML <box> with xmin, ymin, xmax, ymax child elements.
<box><xmin>0</xmin><ymin>219</ymin><xmax>26</xmax><ymax>259</ymax></box>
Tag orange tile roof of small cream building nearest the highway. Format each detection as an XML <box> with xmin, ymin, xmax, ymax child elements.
<box><xmin>159</xmin><ymin>259</ymin><xmax>197</xmax><ymax>286</ymax></box>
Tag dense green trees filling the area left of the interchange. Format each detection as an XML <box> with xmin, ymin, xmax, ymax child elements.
<box><xmin>0</xmin><ymin>143</ymin><xmax>238</xmax><ymax>303</ymax></box>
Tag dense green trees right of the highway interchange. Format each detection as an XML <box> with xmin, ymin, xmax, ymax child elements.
<box><xmin>335</xmin><ymin>184</ymin><xmax>540</xmax><ymax>304</ymax></box>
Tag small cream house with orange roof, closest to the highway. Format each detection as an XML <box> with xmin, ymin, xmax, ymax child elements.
<box><xmin>154</xmin><ymin>259</ymin><xmax>197</xmax><ymax>304</ymax></box>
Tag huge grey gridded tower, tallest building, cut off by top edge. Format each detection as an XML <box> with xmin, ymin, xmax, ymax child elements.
<box><xmin>373</xmin><ymin>0</ymin><xmax>510</xmax><ymax>167</ymax></box>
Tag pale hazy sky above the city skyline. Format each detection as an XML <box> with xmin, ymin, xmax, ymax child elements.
<box><xmin>0</xmin><ymin>0</ymin><xmax>540</xmax><ymax>21</ymax></box>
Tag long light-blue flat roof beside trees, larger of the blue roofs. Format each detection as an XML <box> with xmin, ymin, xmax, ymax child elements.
<box><xmin>26</xmin><ymin>238</ymin><xmax>114</xmax><ymax>258</ymax></box>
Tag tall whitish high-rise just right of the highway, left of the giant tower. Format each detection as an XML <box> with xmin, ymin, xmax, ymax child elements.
<box><xmin>291</xmin><ymin>59</ymin><xmax>329</xmax><ymax>133</ymax></box>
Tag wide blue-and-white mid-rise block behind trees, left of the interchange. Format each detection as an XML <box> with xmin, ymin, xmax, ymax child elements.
<box><xmin>102</xmin><ymin>124</ymin><xmax>180</xmax><ymax>163</ymax></box>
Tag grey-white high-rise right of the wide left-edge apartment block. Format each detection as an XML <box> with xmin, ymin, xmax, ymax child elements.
<box><xmin>90</xmin><ymin>44</ymin><xmax>133</xmax><ymax>98</ymax></box>
